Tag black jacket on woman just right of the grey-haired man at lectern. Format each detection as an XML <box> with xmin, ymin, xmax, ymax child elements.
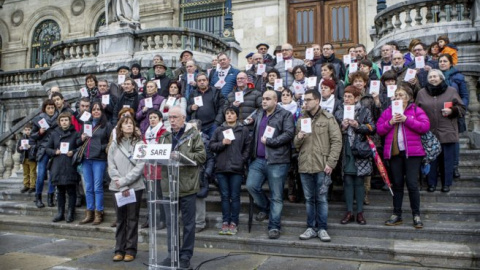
<box><xmin>210</xmin><ymin>123</ymin><xmax>251</xmax><ymax>175</ymax></box>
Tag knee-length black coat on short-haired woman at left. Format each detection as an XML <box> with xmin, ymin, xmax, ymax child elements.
<box><xmin>46</xmin><ymin>125</ymin><xmax>80</xmax><ymax>186</ymax></box>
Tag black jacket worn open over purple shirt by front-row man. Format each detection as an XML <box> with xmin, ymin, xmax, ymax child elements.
<box><xmin>251</xmin><ymin>105</ymin><xmax>295</xmax><ymax>164</ymax></box>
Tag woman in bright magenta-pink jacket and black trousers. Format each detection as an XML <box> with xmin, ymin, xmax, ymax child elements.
<box><xmin>377</xmin><ymin>84</ymin><xmax>430</xmax><ymax>229</ymax></box>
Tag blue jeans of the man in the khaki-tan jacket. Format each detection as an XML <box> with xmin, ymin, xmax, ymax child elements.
<box><xmin>300</xmin><ymin>172</ymin><xmax>328</xmax><ymax>231</ymax></box>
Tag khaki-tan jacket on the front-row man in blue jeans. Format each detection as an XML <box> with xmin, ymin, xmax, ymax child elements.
<box><xmin>293</xmin><ymin>109</ymin><xmax>342</xmax><ymax>173</ymax></box>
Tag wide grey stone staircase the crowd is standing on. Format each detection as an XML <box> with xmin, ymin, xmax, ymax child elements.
<box><xmin>0</xmin><ymin>138</ymin><xmax>480</xmax><ymax>269</ymax></box>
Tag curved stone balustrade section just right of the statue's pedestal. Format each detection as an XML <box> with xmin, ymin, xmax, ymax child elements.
<box><xmin>136</xmin><ymin>28</ymin><xmax>229</xmax><ymax>54</ymax></box>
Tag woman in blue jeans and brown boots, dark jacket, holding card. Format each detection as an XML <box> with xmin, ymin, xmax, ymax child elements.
<box><xmin>77</xmin><ymin>101</ymin><xmax>112</xmax><ymax>225</ymax></box>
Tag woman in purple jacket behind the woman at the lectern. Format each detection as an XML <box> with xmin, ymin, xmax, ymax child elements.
<box><xmin>136</xmin><ymin>81</ymin><xmax>165</xmax><ymax>135</ymax></box>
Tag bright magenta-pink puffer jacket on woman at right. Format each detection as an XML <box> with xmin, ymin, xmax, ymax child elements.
<box><xmin>377</xmin><ymin>104</ymin><xmax>430</xmax><ymax>159</ymax></box>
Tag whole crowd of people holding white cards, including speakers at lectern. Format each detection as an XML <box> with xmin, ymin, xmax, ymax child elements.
<box><xmin>17</xmin><ymin>36</ymin><xmax>469</xmax><ymax>267</ymax></box>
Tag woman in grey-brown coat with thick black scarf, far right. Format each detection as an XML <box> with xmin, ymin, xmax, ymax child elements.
<box><xmin>415</xmin><ymin>69</ymin><xmax>465</xmax><ymax>192</ymax></box>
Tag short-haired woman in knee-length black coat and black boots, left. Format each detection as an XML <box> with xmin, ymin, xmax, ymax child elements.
<box><xmin>46</xmin><ymin>112</ymin><xmax>80</xmax><ymax>223</ymax></box>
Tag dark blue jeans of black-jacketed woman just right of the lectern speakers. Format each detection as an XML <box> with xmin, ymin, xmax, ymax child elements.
<box><xmin>216</xmin><ymin>173</ymin><xmax>243</xmax><ymax>225</ymax></box>
